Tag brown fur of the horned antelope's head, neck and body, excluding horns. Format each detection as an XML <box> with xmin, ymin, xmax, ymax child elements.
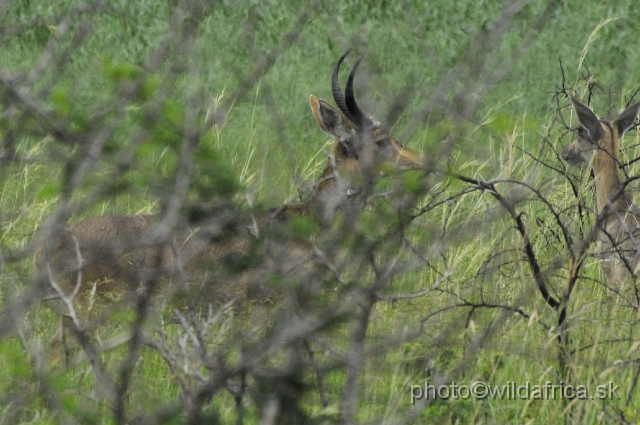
<box><xmin>34</xmin><ymin>63</ymin><xmax>422</xmax><ymax>324</ymax></box>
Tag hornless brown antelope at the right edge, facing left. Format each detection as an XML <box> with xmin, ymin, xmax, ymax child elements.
<box><xmin>562</xmin><ymin>96</ymin><xmax>640</xmax><ymax>282</ymax></box>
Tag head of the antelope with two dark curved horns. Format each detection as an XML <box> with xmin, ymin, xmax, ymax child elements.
<box><xmin>309</xmin><ymin>50</ymin><xmax>423</xmax><ymax>191</ymax></box>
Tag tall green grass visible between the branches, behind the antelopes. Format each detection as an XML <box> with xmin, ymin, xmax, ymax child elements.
<box><xmin>0</xmin><ymin>0</ymin><xmax>640</xmax><ymax>423</ymax></box>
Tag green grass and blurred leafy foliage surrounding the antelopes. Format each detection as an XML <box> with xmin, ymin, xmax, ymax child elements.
<box><xmin>0</xmin><ymin>0</ymin><xmax>640</xmax><ymax>424</ymax></box>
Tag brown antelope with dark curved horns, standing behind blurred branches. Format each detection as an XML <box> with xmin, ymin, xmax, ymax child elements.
<box><xmin>35</xmin><ymin>51</ymin><xmax>422</xmax><ymax>328</ymax></box>
